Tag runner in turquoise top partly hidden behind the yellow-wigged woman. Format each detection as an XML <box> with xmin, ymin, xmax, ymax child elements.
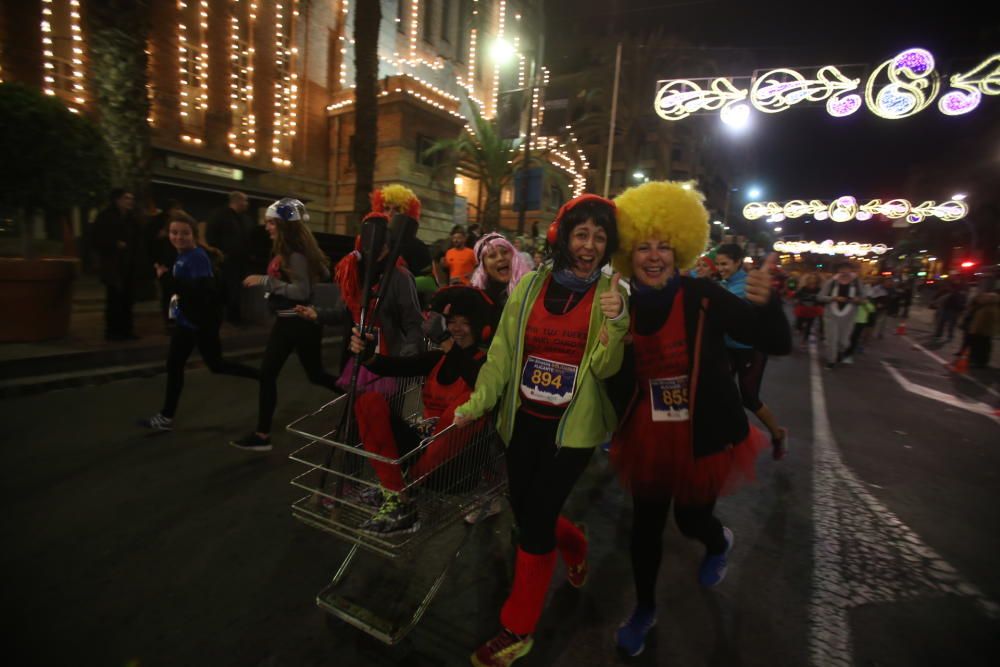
<box><xmin>715</xmin><ymin>243</ymin><xmax>788</xmax><ymax>460</ymax></box>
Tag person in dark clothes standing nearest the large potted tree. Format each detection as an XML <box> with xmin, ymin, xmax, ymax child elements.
<box><xmin>93</xmin><ymin>188</ymin><xmax>141</xmax><ymax>340</ymax></box>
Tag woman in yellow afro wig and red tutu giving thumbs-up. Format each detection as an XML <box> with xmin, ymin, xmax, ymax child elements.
<box><xmin>609</xmin><ymin>177</ymin><xmax>791</xmax><ymax>656</ymax></box>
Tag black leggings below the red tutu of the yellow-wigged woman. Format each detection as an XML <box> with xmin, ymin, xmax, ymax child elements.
<box><xmin>632</xmin><ymin>495</ymin><xmax>726</xmax><ymax>609</ymax></box>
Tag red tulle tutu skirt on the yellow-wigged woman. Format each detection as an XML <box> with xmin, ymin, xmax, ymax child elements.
<box><xmin>611</xmin><ymin>401</ymin><xmax>771</xmax><ymax>505</ymax></box>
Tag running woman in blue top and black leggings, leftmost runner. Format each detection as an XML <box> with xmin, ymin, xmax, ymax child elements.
<box><xmin>139</xmin><ymin>210</ymin><xmax>260</xmax><ymax>431</ymax></box>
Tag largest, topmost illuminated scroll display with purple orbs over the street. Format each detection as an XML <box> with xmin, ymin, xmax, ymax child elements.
<box><xmin>653</xmin><ymin>48</ymin><xmax>1000</xmax><ymax>124</ymax></box>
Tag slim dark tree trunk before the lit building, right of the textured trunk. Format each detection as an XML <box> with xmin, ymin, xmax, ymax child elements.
<box><xmin>353</xmin><ymin>2</ymin><xmax>382</xmax><ymax>231</ymax></box>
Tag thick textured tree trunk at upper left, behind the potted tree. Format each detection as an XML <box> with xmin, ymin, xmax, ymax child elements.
<box><xmin>84</xmin><ymin>0</ymin><xmax>150</xmax><ymax>211</ymax></box>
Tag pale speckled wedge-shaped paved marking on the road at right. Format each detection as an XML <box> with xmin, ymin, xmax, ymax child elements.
<box><xmin>809</xmin><ymin>345</ymin><xmax>1000</xmax><ymax>667</ymax></box>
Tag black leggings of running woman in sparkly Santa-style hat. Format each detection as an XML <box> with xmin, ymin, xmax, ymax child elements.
<box><xmin>257</xmin><ymin>317</ymin><xmax>338</xmax><ymax>433</ymax></box>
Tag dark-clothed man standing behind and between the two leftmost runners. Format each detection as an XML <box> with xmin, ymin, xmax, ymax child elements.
<box><xmin>205</xmin><ymin>191</ymin><xmax>250</xmax><ymax>324</ymax></box>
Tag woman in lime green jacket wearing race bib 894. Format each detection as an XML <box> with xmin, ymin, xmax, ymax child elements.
<box><xmin>455</xmin><ymin>195</ymin><xmax>628</xmax><ymax>667</ymax></box>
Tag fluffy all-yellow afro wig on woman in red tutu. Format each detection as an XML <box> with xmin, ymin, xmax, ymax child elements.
<box><xmin>611</xmin><ymin>181</ymin><xmax>709</xmax><ymax>278</ymax></box>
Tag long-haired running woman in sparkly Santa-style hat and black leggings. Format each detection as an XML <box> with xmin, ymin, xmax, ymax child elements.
<box><xmin>229</xmin><ymin>198</ymin><xmax>337</xmax><ymax>452</ymax></box>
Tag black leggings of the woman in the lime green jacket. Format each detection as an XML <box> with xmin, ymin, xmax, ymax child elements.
<box><xmin>506</xmin><ymin>410</ymin><xmax>594</xmax><ymax>555</ymax></box>
